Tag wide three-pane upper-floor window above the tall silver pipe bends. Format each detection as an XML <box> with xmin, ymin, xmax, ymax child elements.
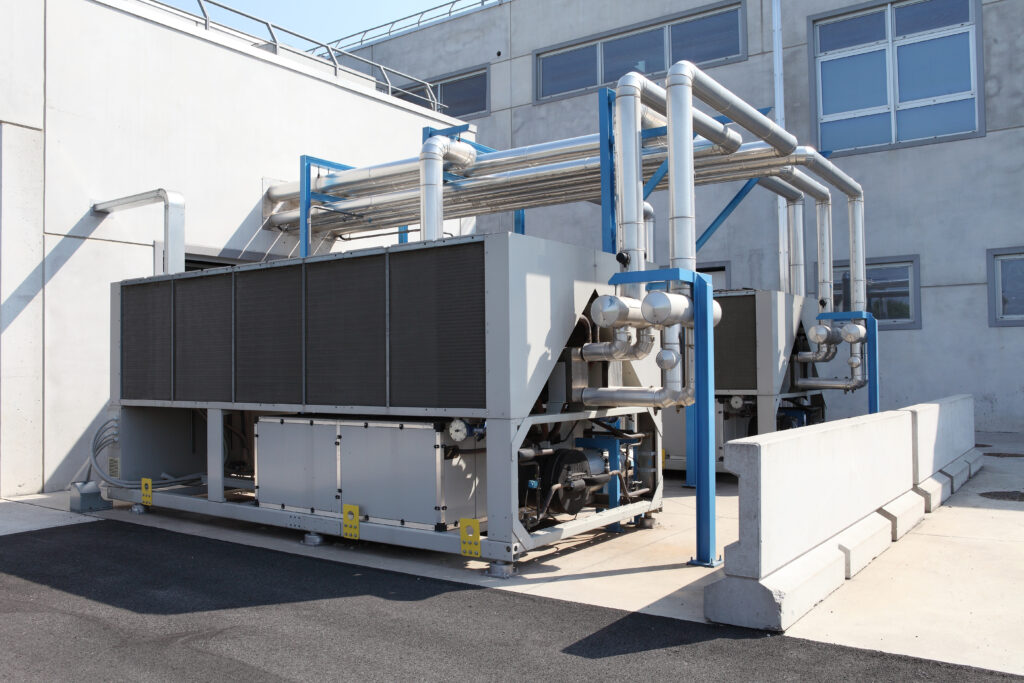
<box><xmin>537</xmin><ymin>3</ymin><xmax>743</xmax><ymax>98</ymax></box>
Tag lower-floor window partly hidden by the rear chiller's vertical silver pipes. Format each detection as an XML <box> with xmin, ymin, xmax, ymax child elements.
<box><xmin>833</xmin><ymin>256</ymin><xmax>921</xmax><ymax>330</ymax></box>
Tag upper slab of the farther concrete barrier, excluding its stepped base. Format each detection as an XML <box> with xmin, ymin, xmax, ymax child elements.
<box><xmin>903</xmin><ymin>394</ymin><xmax>974</xmax><ymax>484</ymax></box>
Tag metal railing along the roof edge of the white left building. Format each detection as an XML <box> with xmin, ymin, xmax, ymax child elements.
<box><xmin>154</xmin><ymin>0</ymin><xmax>442</xmax><ymax>112</ymax></box>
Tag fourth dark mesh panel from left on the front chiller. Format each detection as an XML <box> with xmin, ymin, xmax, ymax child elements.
<box><xmin>306</xmin><ymin>255</ymin><xmax>387</xmax><ymax>405</ymax></box>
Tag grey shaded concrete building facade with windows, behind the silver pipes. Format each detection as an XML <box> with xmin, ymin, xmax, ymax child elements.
<box><xmin>350</xmin><ymin>0</ymin><xmax>1024</xmax><ymax>430</ymax></box>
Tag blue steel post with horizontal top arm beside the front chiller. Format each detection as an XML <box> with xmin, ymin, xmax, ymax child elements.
<box><xmin>608</xmin><ymin>268</ymin><xmax>722</xmax><ymax>567</ymax></box>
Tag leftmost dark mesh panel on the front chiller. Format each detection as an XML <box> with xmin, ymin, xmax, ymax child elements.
<box><xmin>121</xmin><ymin>281</ymin><xmax>171</xmax><ymax>400</ymax></box>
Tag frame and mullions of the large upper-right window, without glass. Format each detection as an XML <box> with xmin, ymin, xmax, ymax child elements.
<box><xmin>807</xmin><ymin>0</ymin><xmax>986</xmax><ymax>157</ymax></box>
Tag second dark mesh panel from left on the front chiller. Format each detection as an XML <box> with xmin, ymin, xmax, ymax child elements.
<box><xmin>174</xmin><ymin>273</ymin><xmax>231</xmax><ymax>401</ymax></box>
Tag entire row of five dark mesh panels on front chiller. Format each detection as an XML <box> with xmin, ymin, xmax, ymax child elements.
<box><xmin>120</xmin><ymin>240</ymin><xmax>486</xmax><ymax>410</ymax></box>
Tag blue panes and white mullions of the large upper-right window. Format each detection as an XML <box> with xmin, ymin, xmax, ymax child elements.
<box><xmin>814</xmin><ymin>0</ymin><xmax>979</xmax><ymax>151</ymax></box>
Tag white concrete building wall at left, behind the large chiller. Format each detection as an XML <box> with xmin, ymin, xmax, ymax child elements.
<box><xmin>0</xmin><ymin>0</ymin><xmax>459</xmax><ymax>495</ymax></box>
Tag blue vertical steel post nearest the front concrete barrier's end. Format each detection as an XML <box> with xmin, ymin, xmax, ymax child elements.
<box><xmin>687</xmin><ymin>273</ymin><xmax>721</xmax><ymax>566</ymax></box>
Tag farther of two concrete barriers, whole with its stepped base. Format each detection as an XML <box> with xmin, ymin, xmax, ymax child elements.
<box><xmin>902</xmin><ymin>394</ymin><xmax>982</xmax><ymax>512</ymax></box>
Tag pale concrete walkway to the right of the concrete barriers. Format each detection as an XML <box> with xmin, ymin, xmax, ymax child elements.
<box><xmin>786</xmin><ymin>433</ymin><xmax>1024</xmax><ymax>674</ymax></box>
